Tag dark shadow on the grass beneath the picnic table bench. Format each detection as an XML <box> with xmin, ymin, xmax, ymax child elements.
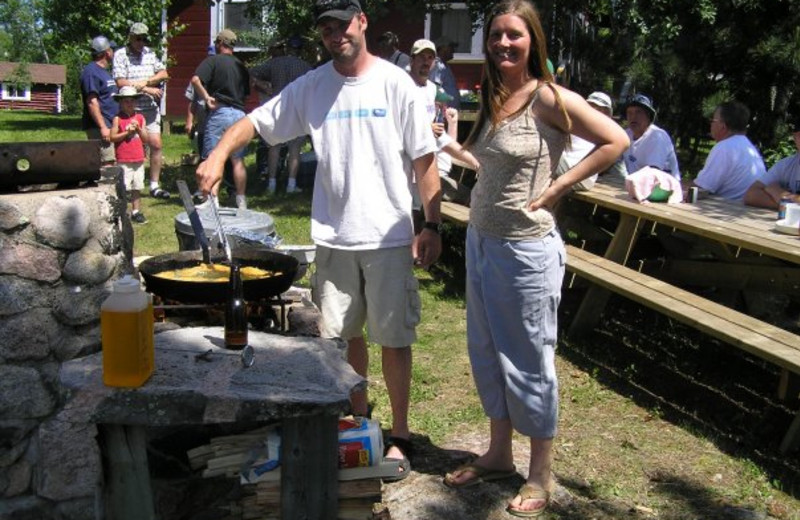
<box><xmin>559</xmin><ymin>290</ymin><xmax>800</xmax><ymax>502</ymax></box>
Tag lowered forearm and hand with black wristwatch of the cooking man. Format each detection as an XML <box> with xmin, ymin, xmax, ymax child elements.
<box><xmin>411</xmin><ymin>153</ymin><xmax>442</xmax><ymax>269</ymax></box>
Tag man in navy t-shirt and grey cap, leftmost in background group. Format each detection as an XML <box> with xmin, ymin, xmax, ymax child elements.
<box><xmin>80</xmin><ymin>36</ymin><xmax>118</xmax><ymax>164</ymax></box>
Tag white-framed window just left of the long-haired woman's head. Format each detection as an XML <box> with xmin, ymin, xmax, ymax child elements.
<box><xmin>425</xmin><ymin>2</ymin><xmax>483</xmax><ymax>62</ymax></box>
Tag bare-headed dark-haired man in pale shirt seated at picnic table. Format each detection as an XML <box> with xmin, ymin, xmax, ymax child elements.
<box><xmin>692</xmin><ymin>101</ymin><xmax>766</xmax><ymax>202</ymax></box>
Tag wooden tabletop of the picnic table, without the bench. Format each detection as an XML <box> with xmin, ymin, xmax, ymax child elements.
<box><xmin>570</xmin><ymin>177</ymin><xmax>800</xmax><ymax>264</ymax></box>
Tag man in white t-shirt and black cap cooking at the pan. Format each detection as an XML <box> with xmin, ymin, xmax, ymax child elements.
<box><xmin>197</xmin><ymin>0</ymin><xmax>442</xmax><ymax>480</ymax></box>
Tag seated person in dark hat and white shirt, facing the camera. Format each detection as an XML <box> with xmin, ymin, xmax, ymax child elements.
<box><xmin>622</xmin><ymin>94</ymin><xmax>681</xmax><ymax>180</ymax></box>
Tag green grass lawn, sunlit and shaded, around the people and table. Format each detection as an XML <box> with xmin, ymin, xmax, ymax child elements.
<box><xmin>0</xmin><ymin>111</ymin><xmax>800</xmax><ymax>520</ymax></box>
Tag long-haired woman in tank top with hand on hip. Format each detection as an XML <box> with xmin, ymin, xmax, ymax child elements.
<box><xmin>444</xmin><ymin>0</ymin><xmax>629</xmax><ymax>518</ymax></box>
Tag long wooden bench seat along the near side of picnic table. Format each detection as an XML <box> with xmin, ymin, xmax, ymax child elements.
<box><xmin>434</xmin><ymin>202</ymin><xmax>800</xmax><ymax>453</ymax></box>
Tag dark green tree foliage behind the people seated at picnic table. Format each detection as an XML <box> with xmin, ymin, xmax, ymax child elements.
<box><xmin>539</xmin><ymin>0</ymin><xmax>800</xmax><ymax>171</ymax></box>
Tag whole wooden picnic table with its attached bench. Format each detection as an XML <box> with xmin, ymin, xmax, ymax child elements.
<box><xmin>441</xmin><ymin>177</ymin><xmax>800</xmax><ymax>452</ymax></box>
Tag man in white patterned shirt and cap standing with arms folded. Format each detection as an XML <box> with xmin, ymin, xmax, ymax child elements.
<box><xmin>113</xmin><ymin>22</ymin><xmax>169</xmax><ymax>199</ymax></box>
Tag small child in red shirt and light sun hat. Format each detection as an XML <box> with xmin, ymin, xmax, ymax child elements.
<box><xmin>111</xmin><ymin>86</ymin><xmax>147</xmax><ymax>224</ymax></box>
